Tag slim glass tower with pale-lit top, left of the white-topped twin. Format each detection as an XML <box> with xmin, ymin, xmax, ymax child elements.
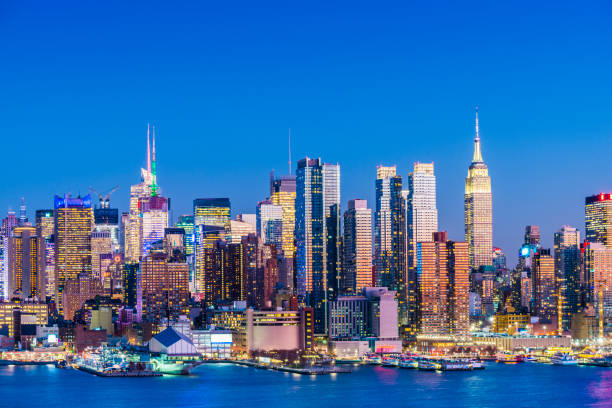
<box><xmin>374</xmin><ymin>166</ymin><xmax>407</xmax><ymax>324</ymax></box>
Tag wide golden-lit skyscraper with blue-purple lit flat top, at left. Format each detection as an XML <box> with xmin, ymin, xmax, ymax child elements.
<box><xmin>54</xmin><ymin>195</ymin><xmax>93</xmax><ymax>318</ymax></box>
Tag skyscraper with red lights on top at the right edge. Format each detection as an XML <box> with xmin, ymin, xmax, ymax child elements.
<box><xmin>584</xmin><ymin>193</ymin><xmax>612</xmax><ymax>248</ymax></box>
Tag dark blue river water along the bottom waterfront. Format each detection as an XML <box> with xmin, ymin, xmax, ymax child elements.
<box><xmin>0</xmin><ymin>363</ymin><xmax>612</xmax><ymax>408</ymax></box>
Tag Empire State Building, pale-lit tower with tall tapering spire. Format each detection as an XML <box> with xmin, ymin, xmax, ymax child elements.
<box><xmin>464</xmin><ymin>108</ymin><xmax>493</xmax><ymax>269</ymax></box>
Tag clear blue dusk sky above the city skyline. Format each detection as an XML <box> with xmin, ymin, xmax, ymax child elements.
<box><xmin>0</xmin><ymin>0</ymin><xmax>612</xmax><ymax>264</ymax></box>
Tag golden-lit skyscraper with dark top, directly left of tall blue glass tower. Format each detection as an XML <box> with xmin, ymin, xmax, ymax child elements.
<box><xmin>270</xmin><ymin>175</ymin><xmax>296</xmax><ymax>288</ymax></box>
